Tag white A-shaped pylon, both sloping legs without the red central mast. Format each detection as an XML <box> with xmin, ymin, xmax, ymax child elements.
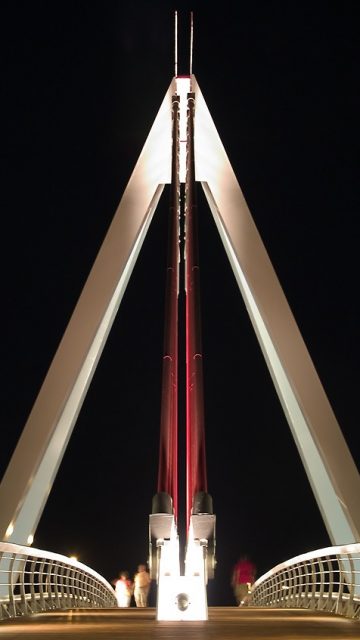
<box><xmin>0</xmin><ymin>76</ymin><xmax>360</xmax><ymax>544</ymax></box>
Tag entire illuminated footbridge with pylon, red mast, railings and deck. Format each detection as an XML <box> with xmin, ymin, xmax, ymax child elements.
<box><xmin>0</xmin><ymin>12</ymin><xmax>360</xmax><ymax>638</ymax></box>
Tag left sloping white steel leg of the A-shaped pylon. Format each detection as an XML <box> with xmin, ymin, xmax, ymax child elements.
<box><xmin>0</xmin><ymin>81</ymin><xmax>175</xmax><ymax>544</ymax></box>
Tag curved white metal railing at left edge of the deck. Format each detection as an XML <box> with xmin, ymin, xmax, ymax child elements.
<box><xmin>0</xmin><ymin>542</ymin><xmax>117</xmax><ymax>619</ymax></box>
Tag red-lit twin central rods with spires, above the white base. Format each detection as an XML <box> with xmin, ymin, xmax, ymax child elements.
<box><xmin>153</xmin><ymin>13</ymin><xmax>212</xmax><ymax>530</ymax></box>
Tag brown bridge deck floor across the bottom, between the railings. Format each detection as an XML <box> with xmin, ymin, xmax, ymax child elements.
<box><xmin>0</xmin><ymin>607</ymin><xmax>360</xmax><ymax>640</ymax></box>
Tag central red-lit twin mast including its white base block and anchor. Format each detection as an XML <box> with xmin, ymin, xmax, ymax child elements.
<box><xmin>149</xmin><ymin>13</ymin><xmax>215</xmax><ymax>620</ymax></box>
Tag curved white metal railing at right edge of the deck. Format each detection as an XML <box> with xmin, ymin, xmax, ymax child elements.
<box><xmin>251</xmin><ymin>544</ymin><xmax>360</xmax><ymax>618</ymax></box>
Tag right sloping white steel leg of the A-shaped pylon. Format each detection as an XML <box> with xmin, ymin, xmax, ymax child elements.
<box><xmin>193</xmin><ymin>79</ymin><xmax>360</xmax><ymax>544</ymax></box>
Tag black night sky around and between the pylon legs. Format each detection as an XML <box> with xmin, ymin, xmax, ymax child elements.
<box><xmin>0</xmin><ymin>0</ymin><xmax>360</xmax><ymax>604</ymax></box>
